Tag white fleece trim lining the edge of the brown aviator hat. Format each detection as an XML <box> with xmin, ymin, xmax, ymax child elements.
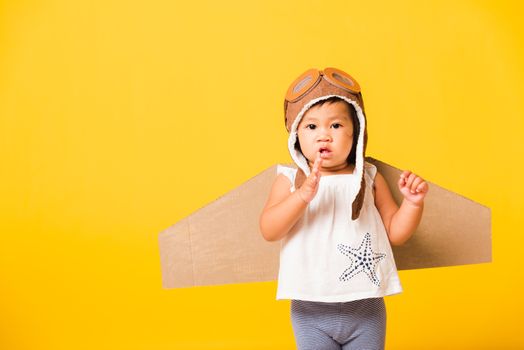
<box><xmin>288</xmin><ymin>95</ymin><xmax>366</xmax><ymax>203</ymax></box>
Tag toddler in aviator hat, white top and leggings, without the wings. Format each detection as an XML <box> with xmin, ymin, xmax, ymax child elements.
<box><xmin>260</xmin><ymin>68</ymin><xmax>428</xmax><ymax>350</ymax></box>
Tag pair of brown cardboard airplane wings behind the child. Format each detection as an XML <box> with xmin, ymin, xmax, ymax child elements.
<box><xmin>159</xmin><ymin>157</ymin><xmax>491</xmax><ymax>288</ymax></box>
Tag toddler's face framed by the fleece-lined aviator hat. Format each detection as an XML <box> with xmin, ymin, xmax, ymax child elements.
<box><xmin>298</xmin><ymin>101</ymin><xmax>353</xmax><ymax>171</ymax></box>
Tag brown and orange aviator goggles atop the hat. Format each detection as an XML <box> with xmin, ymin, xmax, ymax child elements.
<box><xmin>286</xmin><ymin>68</ymin><xmax>360</xmax><ymax>102</ymax></box>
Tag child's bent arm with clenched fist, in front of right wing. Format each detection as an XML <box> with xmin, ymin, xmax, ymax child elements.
<box><xmin>375</xmin><ymin>171</ymin><xmax>428</xmax><ymax>245</ymax></box>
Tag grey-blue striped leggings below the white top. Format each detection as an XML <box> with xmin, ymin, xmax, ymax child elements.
<box><xmin>291</xmin><ymin>297</ymin><xmax>386</xmax><ymax>350</ymax></box>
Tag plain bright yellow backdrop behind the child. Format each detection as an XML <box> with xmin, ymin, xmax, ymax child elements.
<box><xmin>0</xmin><ymin>0</ymin><xmax>524</xmax><ymax>350</ymax></box>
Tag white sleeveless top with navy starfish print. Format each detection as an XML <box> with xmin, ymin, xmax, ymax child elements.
<box><xmin>277</xmin><ymin>162</ymin><xmax>402</xmax><ymax>302</ymax></box>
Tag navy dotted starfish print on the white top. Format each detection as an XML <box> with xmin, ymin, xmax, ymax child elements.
<box><xmin>337</xmin><ymin>233</ymin><xmax>386</xmax><ymax>286</ymax></box>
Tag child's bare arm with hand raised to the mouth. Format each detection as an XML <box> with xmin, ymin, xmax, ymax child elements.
<box><xmin>259</xmin><ymin>154</ymin><xmax>322</xmax><ymax>241</ymax></box>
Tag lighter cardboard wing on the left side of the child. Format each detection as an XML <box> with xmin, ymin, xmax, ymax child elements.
<box><xmin>159</xmin><ymin>166</ymin><xmax>280</xmax><ymax>288</ymax></box>
